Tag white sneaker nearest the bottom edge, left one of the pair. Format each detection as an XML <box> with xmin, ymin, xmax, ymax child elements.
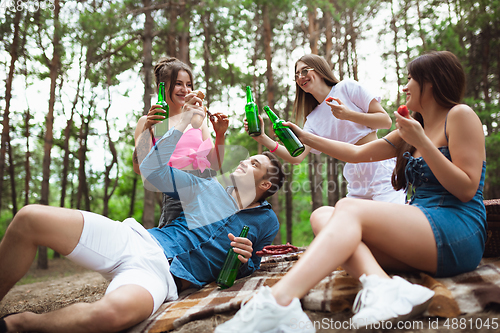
<box><xmin>215</xmin><ymin>286</ymin><xmax>316</xmax><ymax>333</ymax></box>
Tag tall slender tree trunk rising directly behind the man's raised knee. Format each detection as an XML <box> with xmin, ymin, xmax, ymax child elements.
<box><xmin>37</xmin><ymin>0</ymin><xmax>61</xmax><ymax>269</ymax></box>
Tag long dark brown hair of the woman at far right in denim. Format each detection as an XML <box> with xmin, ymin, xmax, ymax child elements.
<box><xmin>392</xmin><ymin>51</ymin><xmax>465</xmax><ymax>190</ymax></box>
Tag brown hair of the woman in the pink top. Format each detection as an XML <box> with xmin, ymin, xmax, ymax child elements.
<box><xmin>154</xmin><ymin>57</ymin><xmax>194</xmax><ymax>99</ymax></box>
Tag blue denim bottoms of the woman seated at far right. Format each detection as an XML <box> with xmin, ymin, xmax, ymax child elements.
<box><xmin>411</xmin><ymin>186</ymin><xmax>486</xmax><ymax>277</ymax></box>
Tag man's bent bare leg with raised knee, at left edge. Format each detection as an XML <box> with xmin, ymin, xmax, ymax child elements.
<box><xmin>0</xmin><ymin>205</ymin><xmax>83</xmax><ymax>300</ymax></box>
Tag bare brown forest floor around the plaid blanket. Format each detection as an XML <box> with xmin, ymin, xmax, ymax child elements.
<box><xmin>0</xmin><ymin>258</ymin><xmax>500</xmax><ymax>333</ymax></box>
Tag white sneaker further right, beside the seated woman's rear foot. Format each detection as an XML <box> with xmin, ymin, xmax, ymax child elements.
<box><xmin>352</xmin><ymin>274</ymin><xmax>434</xmax><ymax>327</ymax></box>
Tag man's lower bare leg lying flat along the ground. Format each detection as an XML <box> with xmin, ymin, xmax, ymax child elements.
<box><xmin>5</xmin><ymin>285</ymin><xmax>154</xmax><ymax>333</ymax></box>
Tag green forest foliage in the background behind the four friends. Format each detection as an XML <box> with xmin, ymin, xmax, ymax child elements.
<box><xmin>0</xmin><ymin>0</ymin><xmax>500</xmax><ymax>245</ymax></box>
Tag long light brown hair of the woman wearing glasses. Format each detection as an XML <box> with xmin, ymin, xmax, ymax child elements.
<box><xmin>293</xmin><ymin>54</ymin><xmax>339</xmax><ymax>123</ymax></box>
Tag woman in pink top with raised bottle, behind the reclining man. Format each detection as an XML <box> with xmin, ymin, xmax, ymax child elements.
<box><xmin>133</xmin><ymin>58</ymin><xmax>229</xmax><ymax>228</ymax></box>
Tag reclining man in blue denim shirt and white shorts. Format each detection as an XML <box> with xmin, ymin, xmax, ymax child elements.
<box><xmin>0</xmin><ymin>96</ymin><xmax>284</xmax><ymax>332</ymax></box>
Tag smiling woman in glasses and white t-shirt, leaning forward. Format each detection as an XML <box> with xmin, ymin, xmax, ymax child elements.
<box><xmin>245</xmin><ymin>54</ymin><xmax>406</xmax><ymax>234</ymax></box>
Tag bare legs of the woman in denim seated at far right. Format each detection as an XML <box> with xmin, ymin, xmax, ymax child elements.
<box><xmin>273</xmin><ymin>198</ymin><xmax>437</xmax><ymax>305</ymax></box>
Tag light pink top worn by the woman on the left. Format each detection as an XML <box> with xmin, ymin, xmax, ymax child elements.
<box><xmin>168</xmin><ymin>128</ymin><xmax>212</xmax><ymax>172</ymax></box>
